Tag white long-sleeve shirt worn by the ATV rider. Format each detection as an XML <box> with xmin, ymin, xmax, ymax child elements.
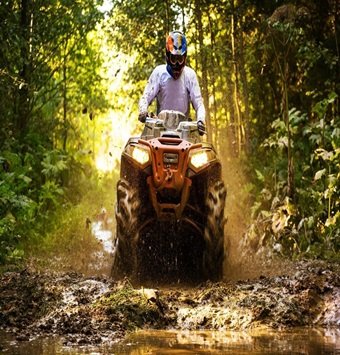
<box><xmin>139</xmin><ymin>64</ymin><xmax>205</xmax><ymax>122</ymax></box>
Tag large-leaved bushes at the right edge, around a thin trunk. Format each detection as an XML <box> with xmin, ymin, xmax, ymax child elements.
<box><xmin>248</xmin><ymin>93</ymin><xmax>340</xmax><ymax>257</ymax></box>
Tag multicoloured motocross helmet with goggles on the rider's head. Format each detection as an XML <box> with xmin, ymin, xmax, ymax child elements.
<box><xmin>166</xmin><ymin>31</ymin><xmax>187</xmax><ymax>79</ymax></box>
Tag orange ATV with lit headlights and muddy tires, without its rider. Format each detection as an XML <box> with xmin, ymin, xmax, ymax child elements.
<box><xmin>112</xmin><ymin>110</ymin><xmax>226</xmax><ymax>281</ymax></box>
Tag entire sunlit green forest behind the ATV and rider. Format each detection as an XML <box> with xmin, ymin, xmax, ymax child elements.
<box><xmin>0</xmin><ymin>0</ymin><xmax>340</xmax><ymax>265</ymax></box>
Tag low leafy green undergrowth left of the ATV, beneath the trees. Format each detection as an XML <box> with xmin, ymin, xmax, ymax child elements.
<box><xmin>0</xmin><ymin>134</ymin><xmax>115</xmax><ymax>264</ymax></box>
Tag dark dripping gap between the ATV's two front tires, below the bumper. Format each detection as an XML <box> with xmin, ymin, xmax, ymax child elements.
<box><xmin>137</xmin><ymin>221</ymin><xmax>204</xmax><ymax>284</ymax></box>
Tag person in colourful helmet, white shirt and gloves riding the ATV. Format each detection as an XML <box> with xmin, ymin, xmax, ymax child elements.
<box><xmin>138</xmin><ymin>31</ymin><xmax>205</xmax><ymax>135</ymax></box>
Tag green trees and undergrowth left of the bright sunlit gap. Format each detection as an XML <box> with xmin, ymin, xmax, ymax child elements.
<box><xmin>0</xmin><ymin>0</ymin><xmax>107</xmax><ymax>263</ymax></box>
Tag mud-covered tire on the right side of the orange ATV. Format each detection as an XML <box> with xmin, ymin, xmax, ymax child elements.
<box><xmin>202</xmin><ymin>180</ymin><xmax>227</xmax><ymax>281</ymax></box>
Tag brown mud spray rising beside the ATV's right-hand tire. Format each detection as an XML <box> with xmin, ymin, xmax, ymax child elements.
<box><xmin>219</xmin><ymin>137</ymin><xmax>294</xmax><ymax>281</ymax></box>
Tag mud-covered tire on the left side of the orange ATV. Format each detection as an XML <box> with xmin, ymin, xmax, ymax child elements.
<box><xmin>111</xmin><ymin>179</ymin><xmax>140</xmax><ymax>278</ymax></box>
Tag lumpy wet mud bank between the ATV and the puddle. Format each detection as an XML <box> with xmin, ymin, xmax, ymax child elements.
<box><xmin>0</xmin><ymin>261</ymin><xmax>340</xmax><ymax>345</ymax></box>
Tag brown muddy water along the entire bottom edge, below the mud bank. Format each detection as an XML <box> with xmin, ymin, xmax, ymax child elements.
<box><xmin>0</xmin><ymin>328</ymin><xmax>340</xmax><ymax>355</ymax></box>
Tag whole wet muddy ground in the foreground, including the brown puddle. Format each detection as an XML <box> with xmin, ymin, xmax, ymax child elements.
<box><xmin>0</xmin><ymin>220</ymin><xmax>340</xmax><ymax>354</ymax></box>
